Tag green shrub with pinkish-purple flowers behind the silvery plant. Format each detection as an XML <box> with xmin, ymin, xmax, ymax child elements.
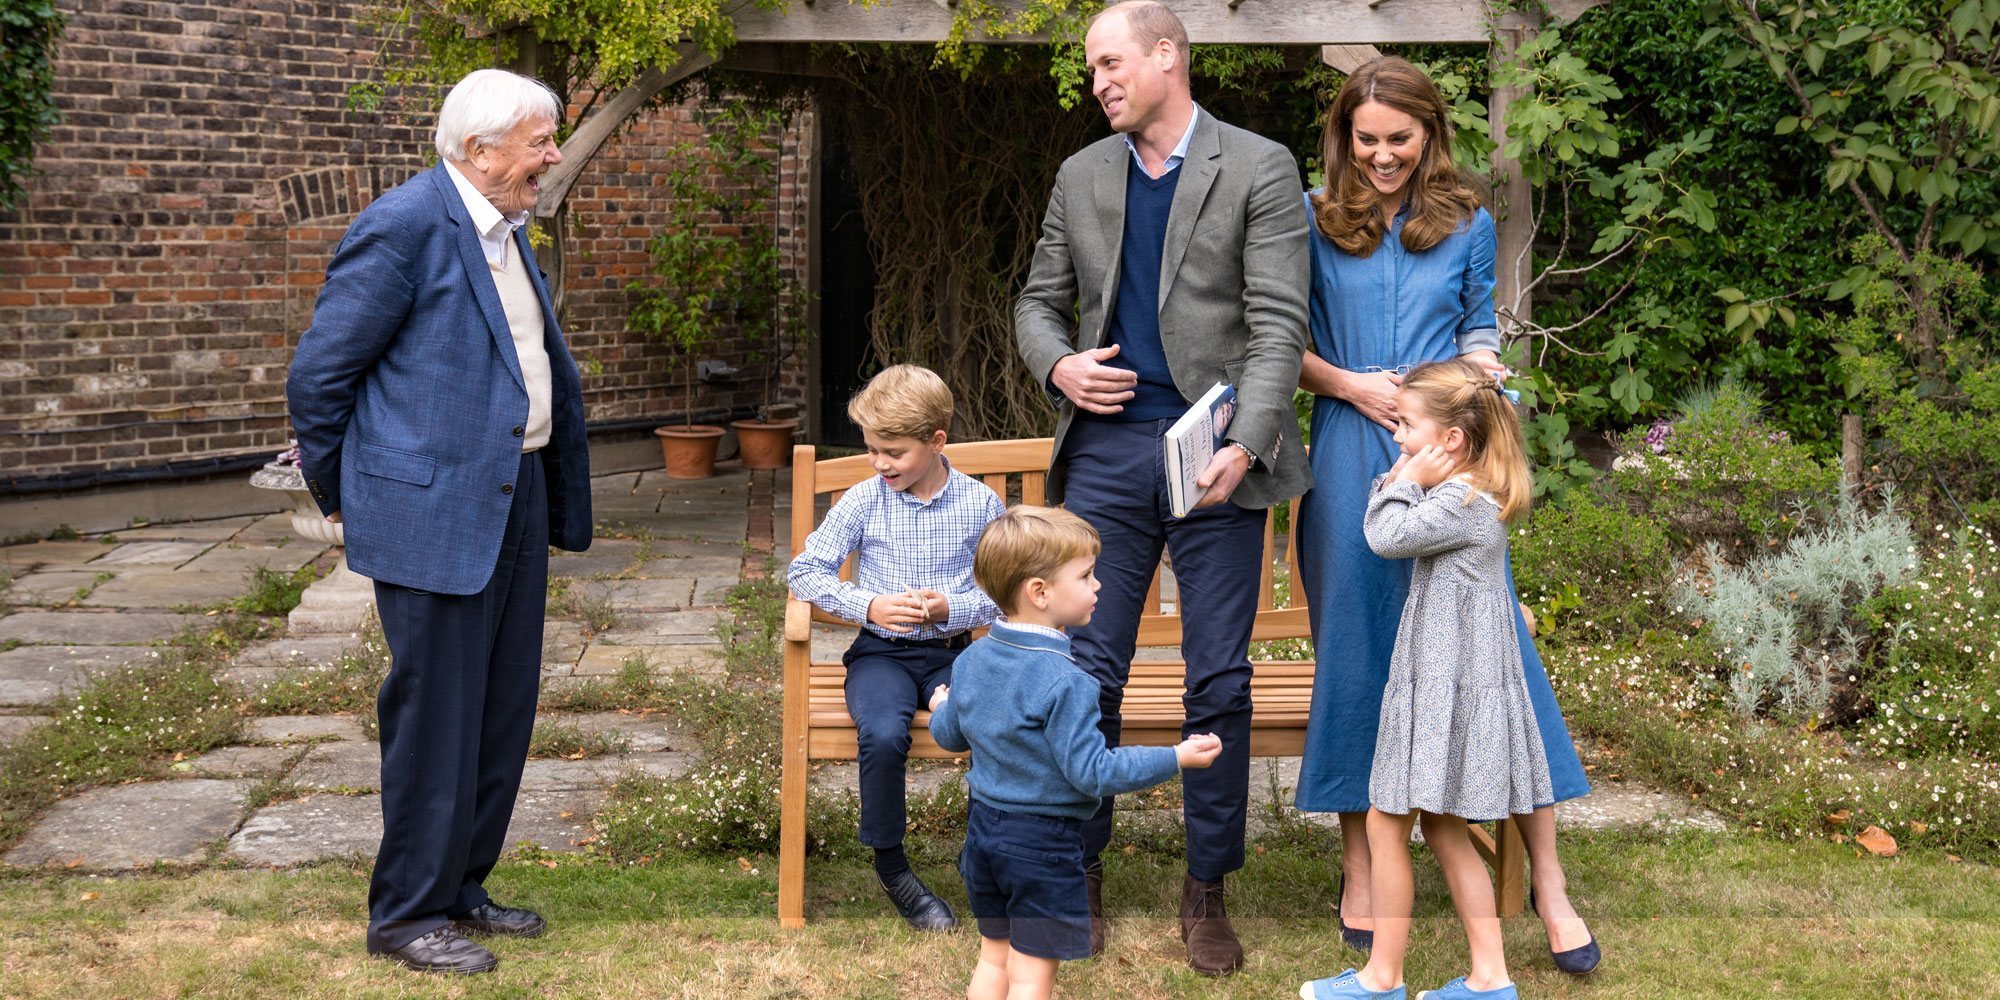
<box><xmin>1612</xmin><ymin>382</ymin><xmax>1840</xmax><ymax>550</ymax></box>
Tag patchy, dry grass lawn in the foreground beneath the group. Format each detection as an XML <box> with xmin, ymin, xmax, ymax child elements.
<box><xmin>0</xmin><ymin>832</ymin><xmax>2000</xmax><ymax>1000</ymax></box>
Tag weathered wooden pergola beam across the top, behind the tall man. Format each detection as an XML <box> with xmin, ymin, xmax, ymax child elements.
<box><xmin>730</xmin><ymin>0</ymin><xmax>1600</xmax><ymax>46</ymax></box>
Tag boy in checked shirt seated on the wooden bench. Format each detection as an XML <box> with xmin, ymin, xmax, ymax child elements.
<box><xmin>786</xmin><ymin>364</ymin><xmax>1002</xmax><ymax>930</ymax></box>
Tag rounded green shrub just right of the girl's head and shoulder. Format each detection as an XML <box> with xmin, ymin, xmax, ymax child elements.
<box><xmin>1510</xmin><ymin>486</ymin><xmax>1674</xmax><ymax>634</ymax></box>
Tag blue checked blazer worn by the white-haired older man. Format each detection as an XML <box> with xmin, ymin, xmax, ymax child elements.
<box><xmin>284</xmin><ymin>164</ymin><xmax>590</xmax><ymax>594</ymax></box>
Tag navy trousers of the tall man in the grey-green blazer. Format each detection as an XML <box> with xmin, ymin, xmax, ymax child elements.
<box><xmin>1062</xmin><ymin>420</ymin><xmax>1264</xmax><ymax>882</ymax></box>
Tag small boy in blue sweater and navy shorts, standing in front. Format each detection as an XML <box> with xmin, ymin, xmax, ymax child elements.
<box><xmin>930</xmin><ymin>506</ymin><xmax>1222</xmax><ymax>1000</ymax></box>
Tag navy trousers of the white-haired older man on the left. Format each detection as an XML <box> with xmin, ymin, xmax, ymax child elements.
<box><xmin>368</xmin><ymin>452</ymin><xmax>548</xmax><ymax>952</ymax></box>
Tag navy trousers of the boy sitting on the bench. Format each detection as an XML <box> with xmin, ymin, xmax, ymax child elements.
<box><xmin>840</xmin><ymin>628</ymin><xmax>964</xmax><ymax>848</ymax></box>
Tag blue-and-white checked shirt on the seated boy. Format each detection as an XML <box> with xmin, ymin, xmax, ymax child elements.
<box><xmin>786</xmin><ymin>458</ymin><xmax>1006</xmax><ymax>638</ymax></box>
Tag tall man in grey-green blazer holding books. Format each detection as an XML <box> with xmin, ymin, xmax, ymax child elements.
<box><xmin>1014</xmin><ymin>0</ymin><xmax>1312</xmax><ymax>974</ymax></box>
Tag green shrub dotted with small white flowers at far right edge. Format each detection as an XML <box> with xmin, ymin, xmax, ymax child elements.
<box><xmin>1860</xmin><ymin>532</ymin><xmax>2000</xmax><ymax>760</ymax></box>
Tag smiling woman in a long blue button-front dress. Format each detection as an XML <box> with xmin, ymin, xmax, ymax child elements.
<box><xmin>1298</xmin><ymin>56</ymin><xmax>1598</xmax><ymax>972</ymax></box>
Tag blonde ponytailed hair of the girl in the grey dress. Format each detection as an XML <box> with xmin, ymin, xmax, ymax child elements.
<box><xmin>1402</xmin><ymin>358</ymin><xmax>1534</xmax><ymax>522</ymax></box>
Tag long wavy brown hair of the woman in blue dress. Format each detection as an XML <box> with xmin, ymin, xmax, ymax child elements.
<box><xmin>1312</xmin><ymin>56</ymin><xmax>1480</xmax><ymax>256</ymax></box>
